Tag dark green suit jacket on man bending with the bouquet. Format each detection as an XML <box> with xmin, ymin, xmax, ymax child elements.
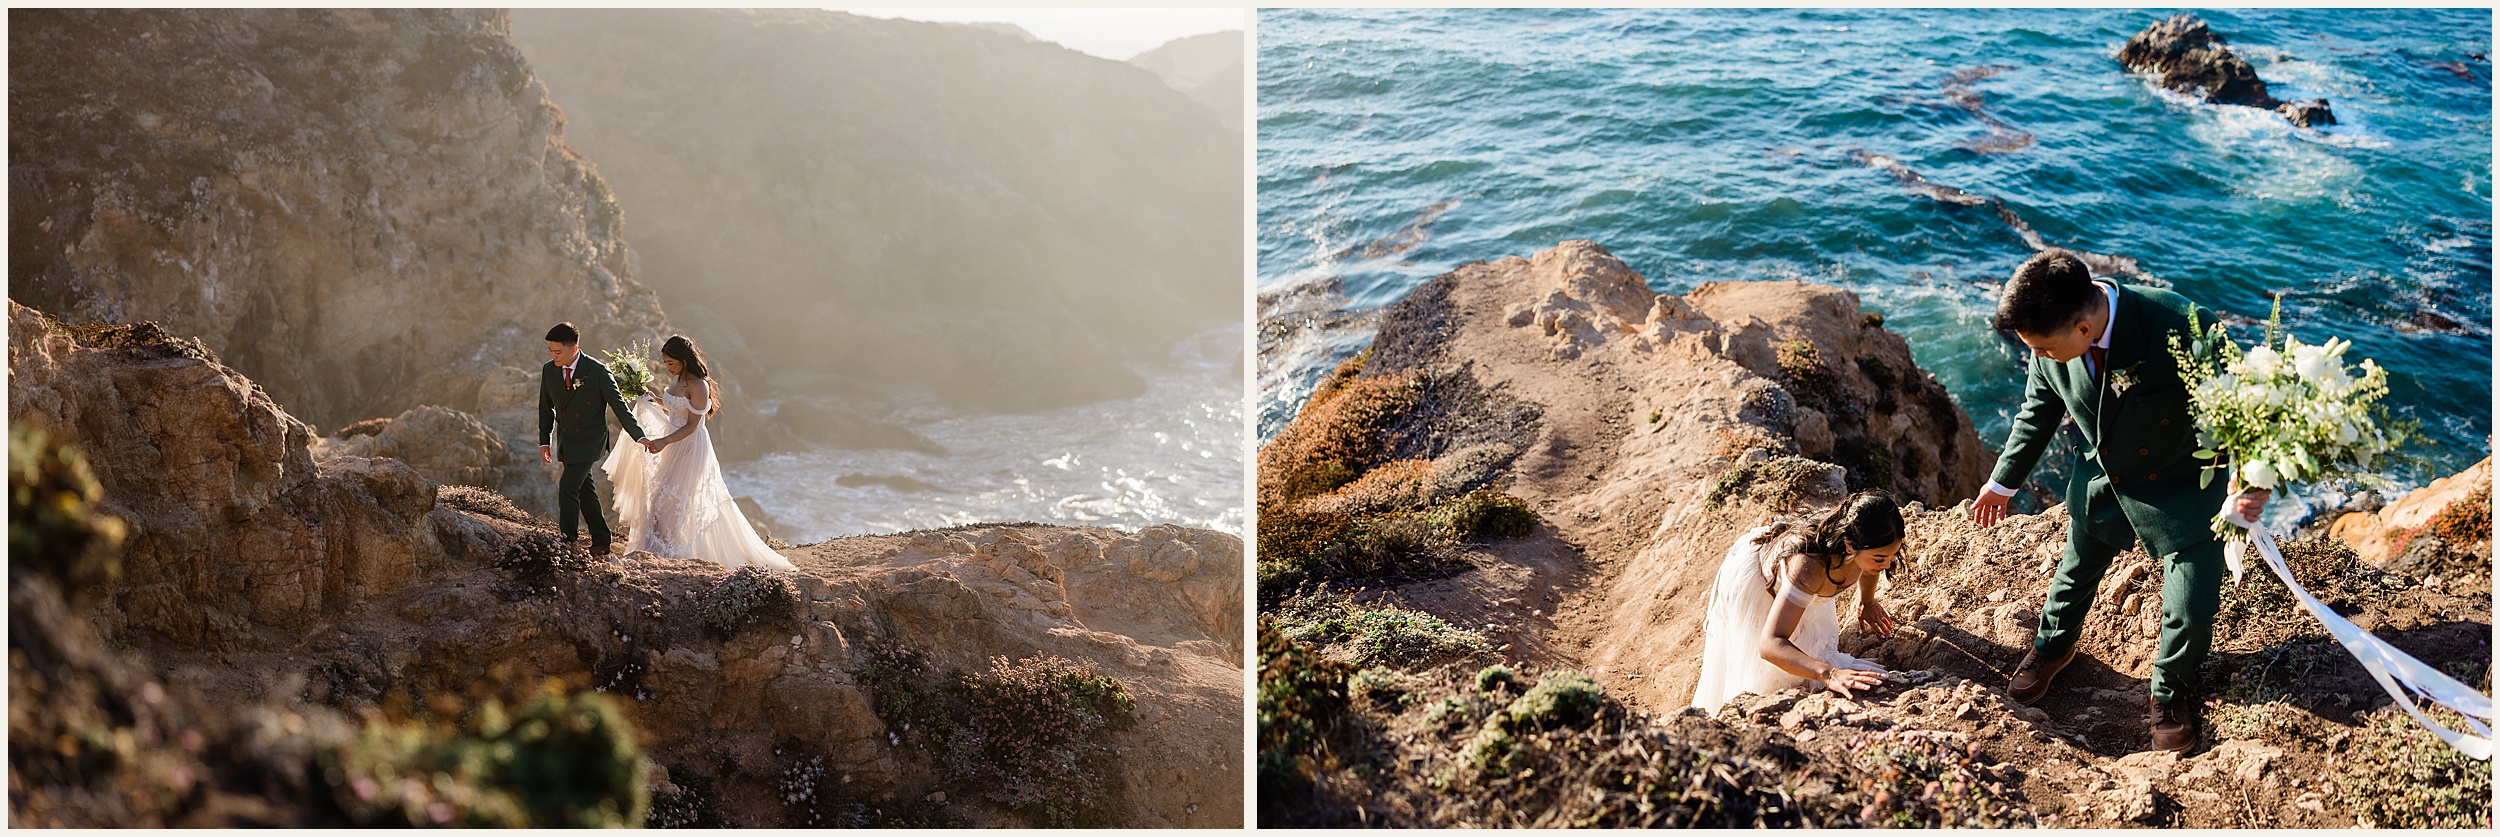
<box><xmin>1990</xmin><ymin>285</ymin><xmax>2228</xmax><ymax>555</ymax></box>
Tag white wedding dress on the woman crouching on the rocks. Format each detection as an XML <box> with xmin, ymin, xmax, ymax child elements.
<box><xmin>1693</xmin><ymin>527</ymin><xmax>1883</xmax><ymax>712</ymax></box>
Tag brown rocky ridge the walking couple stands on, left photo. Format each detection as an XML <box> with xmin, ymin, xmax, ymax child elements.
<box><xmin>10</xmin><ymin>305</ymin><xmax>1243</xmax><ymax>827</ymax></box>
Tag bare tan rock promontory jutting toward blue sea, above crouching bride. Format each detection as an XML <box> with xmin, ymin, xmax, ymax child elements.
<box><xmin>1330</xmin><ymin>240</ymin><xmax>1993</xmax><ymax>705</ymax></box>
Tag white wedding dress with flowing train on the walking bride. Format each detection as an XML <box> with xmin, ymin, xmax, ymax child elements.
<box><xmin>600</xmin><ymin>384</ymin><xmax>798</xmax><ymax>570</ymax></box>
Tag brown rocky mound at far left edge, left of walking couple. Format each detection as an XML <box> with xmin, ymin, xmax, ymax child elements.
<box><xmin>8</xmin><ymin>302</ymin><xmax>478</xmax><ymax>650</ymax></box>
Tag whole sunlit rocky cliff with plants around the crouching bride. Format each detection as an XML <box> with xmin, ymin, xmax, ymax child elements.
<box><xmin>1258</xmin><ymin>242</ymin><xmax>2490</xmax><ymax>827</ymax></box>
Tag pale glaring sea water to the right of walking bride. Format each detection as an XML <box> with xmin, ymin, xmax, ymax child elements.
<box><xmin>723</xmin><ymin>325</ymin><xmax>1248</xmax><ymax>542</ymax></box>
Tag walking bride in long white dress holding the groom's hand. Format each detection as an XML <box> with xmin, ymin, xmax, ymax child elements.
<box><xmin>600</xmin><ymin>335</ymin><xmax>798</xmax><ymax>570</ymax></box>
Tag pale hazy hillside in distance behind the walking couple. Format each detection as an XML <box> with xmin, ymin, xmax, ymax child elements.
<box><xmin>513</xmin><ymin>10</ymin><xmax>1243</xmax><ymax>410</ymax></box>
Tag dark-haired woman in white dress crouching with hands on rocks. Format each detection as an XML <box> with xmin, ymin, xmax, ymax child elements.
<box><xmin>1693</xmin><ymin>492</ymin><xmax>1903</xmax><ymax>712</ymax></box>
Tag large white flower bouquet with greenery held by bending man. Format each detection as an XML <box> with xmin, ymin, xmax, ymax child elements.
<box><xmin>2170</xmin><ymin>297</ymin><xmax>2413</xmax><ymax>537</ymax></box>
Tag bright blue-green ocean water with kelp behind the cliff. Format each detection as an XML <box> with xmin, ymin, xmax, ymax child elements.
<box><xmin>1258</xmin><ymin>10</ymin><xmax>2493</xmax><ymax>514</ymax></box>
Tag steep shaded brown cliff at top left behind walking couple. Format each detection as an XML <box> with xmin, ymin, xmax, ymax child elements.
<box><xmin>10</xmin><ymin>10</ymin><xmax>668</xmax><ymax>427</ymax></box>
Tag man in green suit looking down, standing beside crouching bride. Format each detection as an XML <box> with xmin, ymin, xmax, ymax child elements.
<box><xmin>1970</xmin><ymin>250</ymin><xmax>2268</xmax><ymax>752</ymax></box>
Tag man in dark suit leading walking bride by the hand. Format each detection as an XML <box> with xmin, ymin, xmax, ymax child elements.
<box><xmin>538</xmin><ymin>322</ymin><xmax>643</xmax><ymax>555</ymax></box>
